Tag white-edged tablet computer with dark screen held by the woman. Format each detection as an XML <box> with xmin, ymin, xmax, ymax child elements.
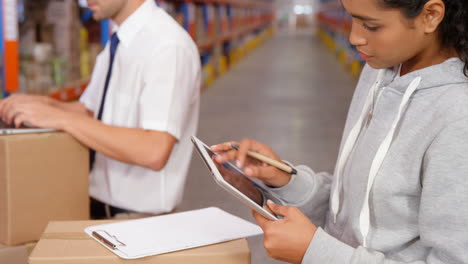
<box><xmin>192</xmin><ymin>136</ymin><xmax>278</xmax><ymax>220</ymax></box>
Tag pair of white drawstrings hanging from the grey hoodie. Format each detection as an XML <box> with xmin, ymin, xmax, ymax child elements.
<box><xmin>331</xmin><ymin>70</ymin><xmax>421</xmax><ymax>247</ymax></box>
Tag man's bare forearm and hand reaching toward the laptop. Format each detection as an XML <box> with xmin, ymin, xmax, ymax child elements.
<box><xmin>10</xmin><ymin>103</ymin><xmax>177</xmax><ymax>170</ymax></box>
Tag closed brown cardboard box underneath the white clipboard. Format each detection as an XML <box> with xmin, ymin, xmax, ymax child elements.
<box><xmin>29</xmin><ymin>221</ymin><xmax>250</xmax><ymax>264</ymax></box>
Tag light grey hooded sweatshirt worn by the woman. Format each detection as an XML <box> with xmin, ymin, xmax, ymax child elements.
<box><xmin>270</xmin><ymin>58</ymin><xmax>468</xmax><ymax>264</ymax></box>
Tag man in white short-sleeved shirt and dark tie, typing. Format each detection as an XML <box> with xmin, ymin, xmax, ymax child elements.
<box><xmin>0</xmin><ymin>0</ymin><xmax>201</xmax><ymax>218</ymax></box>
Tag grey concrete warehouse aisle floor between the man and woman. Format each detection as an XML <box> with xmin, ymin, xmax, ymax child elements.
<box><xmin>180</xmin><ymin>23</ymin><xmax>356</xmax><ymax>264</ymax></box>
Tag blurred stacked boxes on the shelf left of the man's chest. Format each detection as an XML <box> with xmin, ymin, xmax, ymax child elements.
<box><xmin>20</xmin><ymin>0</ymin><xmax>97</xmax><ymax>94</ymax></box>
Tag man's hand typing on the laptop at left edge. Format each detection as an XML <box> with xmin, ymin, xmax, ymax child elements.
<box><xmin>1</xmin><ymin>102</ymin><xmax>70</xmax><ymax>130</ymax></box>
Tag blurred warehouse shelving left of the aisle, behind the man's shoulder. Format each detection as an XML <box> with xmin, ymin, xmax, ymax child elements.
<box><xmin>166</xmin><ymin>0</ymin><xmax>274</xmax><ymax>88</ymax></box>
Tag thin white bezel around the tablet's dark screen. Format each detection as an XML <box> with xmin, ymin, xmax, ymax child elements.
<box><xmin>192</xmin><ymin>136</ymin><xmax>278</xmax><ymax>220</ymax></box>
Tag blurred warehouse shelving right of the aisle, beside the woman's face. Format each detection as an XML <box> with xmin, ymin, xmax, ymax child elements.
<box><xmin>317</xmin><ymin>0</ymin><xmax>365</xmax><ymax>77</ymax></box>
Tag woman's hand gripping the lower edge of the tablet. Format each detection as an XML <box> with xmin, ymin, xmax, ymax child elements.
<box><xmin>252</xmin><ymin>201</ymin><xmax>317</xmax><ymax>263</ymax></box>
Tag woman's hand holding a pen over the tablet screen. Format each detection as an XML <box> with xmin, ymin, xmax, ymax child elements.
<box><xmin>211</xmin><ymin>139</ymin><xmax>291</xmax><ymax>187</ymax></box>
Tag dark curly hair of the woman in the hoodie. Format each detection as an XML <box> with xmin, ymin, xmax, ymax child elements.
<box><xmin>378</xmin><ymin>0</ymin><xmax>468</xmax><ymax>77</ymax></box>
